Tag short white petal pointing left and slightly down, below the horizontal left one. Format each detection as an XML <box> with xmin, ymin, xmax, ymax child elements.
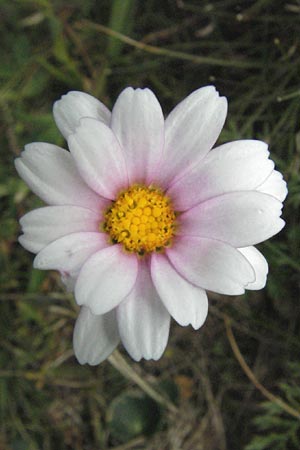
<box><xmin>33</xmin><ymin>232</ymin><xmax>108</xmax><ymax>272</ymax></box>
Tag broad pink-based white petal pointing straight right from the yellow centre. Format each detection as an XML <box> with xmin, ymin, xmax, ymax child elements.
<box><xmin>178</xmin><ymin>191</ymin><xmax>285</xmax><ymax>247</ymax></box>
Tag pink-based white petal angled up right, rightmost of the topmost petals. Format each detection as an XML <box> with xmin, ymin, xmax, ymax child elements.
<box><xmin>160</xmin><ymin>86</ymin><xmax>227</xmax><ymax>187</ymax></box>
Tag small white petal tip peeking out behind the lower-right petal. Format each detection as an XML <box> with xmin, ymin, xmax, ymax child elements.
<box><xmin>238</xmin><ymin>247</ymin><xmax>269</xmax><ymax>291</ymax></box>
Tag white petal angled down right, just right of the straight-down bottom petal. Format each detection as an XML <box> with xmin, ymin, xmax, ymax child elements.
<box><xmin>151</xmin><ymin>253</ymin><xmax>208</xmax><ymax>330</ymax></box>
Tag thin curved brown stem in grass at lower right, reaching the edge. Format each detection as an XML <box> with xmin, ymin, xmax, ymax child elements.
<box><xmin>224</xmin><ymin>316</ymin><xmax>300</xmax><ymax>420</ymax></box>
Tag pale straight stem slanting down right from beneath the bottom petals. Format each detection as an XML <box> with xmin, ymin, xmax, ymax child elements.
<box><xmin>108</xmin><ymin>350</ymin><xmax>178</xmax><ymax>413</ymax></box>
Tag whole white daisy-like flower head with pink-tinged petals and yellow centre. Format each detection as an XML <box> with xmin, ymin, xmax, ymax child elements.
<box><xmin>16</xmin><ymin>86</ymin><xmax>287</xmax><ymax>364</ymax></box>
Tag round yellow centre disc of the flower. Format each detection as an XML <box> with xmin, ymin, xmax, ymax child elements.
<box><xmin>103</xmin><ymin>185</ymin><xmax>176</xmax><ymax>255</ymax></box>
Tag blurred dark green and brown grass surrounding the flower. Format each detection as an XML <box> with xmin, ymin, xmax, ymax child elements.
<box><xmin>0</xmin><ymin>0</ymin><xmax>300</xmax><ymax>450</ymax></box>
